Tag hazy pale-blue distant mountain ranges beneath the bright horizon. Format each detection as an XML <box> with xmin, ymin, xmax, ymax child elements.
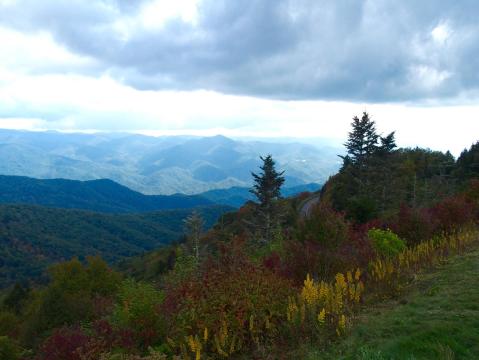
<box><xmin>0</xmin><ymin>129</ymin><xmax>342</xmax><ymax>195</ymax></box>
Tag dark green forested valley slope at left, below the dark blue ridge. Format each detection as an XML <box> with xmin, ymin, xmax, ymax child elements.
<box><xmin>0</xmin><ymin>205</ymin><xmax>231</xmax><ymax>288</ymax></box>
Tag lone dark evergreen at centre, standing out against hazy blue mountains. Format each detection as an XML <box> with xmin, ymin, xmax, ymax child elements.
<box><xmin>250</xmin><ymin>155</ymin><xmax>285</xmax><ymax>242</ymax></box>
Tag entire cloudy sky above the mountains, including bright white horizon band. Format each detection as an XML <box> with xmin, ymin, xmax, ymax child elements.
<box><xmin>0</xmin><ymin>0</ymin><xmax>479</xmax><ymax>154</ymax></box>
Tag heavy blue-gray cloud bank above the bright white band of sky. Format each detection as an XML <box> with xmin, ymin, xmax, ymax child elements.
<box><xmin>0</xmin><ymin>0</ymin><xmax>479</xmax><ymax>102</ymax></box>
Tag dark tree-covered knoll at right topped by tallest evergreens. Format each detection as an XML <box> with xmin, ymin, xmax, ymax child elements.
<box><xmin>322</xmin><ymin>113</ymin><xmax>462</xmax><ymax>223</ymax></box>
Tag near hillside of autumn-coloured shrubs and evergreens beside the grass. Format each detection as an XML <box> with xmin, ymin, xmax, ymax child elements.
<box><xmin>0</xmin><ymin>113</ymin><xmax>479</xmax><ymax>360</ymax></box>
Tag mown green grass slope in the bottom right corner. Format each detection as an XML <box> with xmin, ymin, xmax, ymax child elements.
<box><xmin>304</xmin><ymin>250</ymin><xmax>479</xmax><ymax>360</ymax></box>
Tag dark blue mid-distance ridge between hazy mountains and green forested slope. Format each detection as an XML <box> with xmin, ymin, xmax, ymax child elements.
<box><xmin>0</xmin><ymin>175</ymin><xmax>213</xmax><ymax>213</ymax></box>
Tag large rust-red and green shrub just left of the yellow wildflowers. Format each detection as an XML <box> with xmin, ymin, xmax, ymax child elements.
<box><xmin>165</xmin><ymin>243</ymin><xmax>293</xmax><ymax>358</ymax></box>
